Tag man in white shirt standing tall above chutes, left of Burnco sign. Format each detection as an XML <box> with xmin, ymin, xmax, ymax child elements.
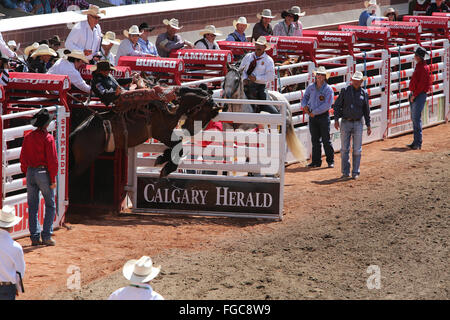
<box><xmin>65</xmin><ymin>5</ymin><xmax>105</xmax><ymax>60</ymax></box>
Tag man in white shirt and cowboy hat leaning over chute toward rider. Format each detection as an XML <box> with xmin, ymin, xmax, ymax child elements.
<box><xmin>47</xmin><ymin>50</ymin><xmax>91</xmax><ymax>93</ymax></box>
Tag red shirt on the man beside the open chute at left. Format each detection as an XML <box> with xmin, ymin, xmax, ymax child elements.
<box><xmin>20</xmin><ymin>129</ymin><xmax>58</xmax><ymax>184</ymax></box>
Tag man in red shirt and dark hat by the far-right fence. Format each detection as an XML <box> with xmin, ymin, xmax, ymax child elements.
<box><xmin>407</xmin><ymin>47</ymin><xmax>431</xmax><ymax>150</ymax></box>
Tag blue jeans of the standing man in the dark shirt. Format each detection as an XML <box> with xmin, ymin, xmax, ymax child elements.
<box><xmin>341</xmin><ymin>118</ymin><xmax>363</xmax><ymax>176</ymax></box>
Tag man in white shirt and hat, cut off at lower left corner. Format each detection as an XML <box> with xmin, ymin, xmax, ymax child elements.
<box><xmin>0</xmin><ymin>205</ymin><xmax>25</xmax><ymax>300</ymax></box>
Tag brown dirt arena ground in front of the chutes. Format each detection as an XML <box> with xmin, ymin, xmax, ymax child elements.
<box><xmin>15</xmin><ymin>124</ymin><xmax>450</xmax><ymax>299</ymax></box>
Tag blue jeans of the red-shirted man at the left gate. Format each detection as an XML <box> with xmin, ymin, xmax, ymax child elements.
<box><xmin>27</xmin><ymin>168</ymin><xmax>55</xmax><ymax>241</ymax></box>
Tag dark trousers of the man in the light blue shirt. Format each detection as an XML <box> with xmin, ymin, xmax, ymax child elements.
<box><xmin>309</xmin><ymin>113</ymin><xmax>334</xmax><ymax>165</ymax></box>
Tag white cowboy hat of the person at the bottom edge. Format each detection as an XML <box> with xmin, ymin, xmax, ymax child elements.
<box><xmin>122</xmin><ymin>256</ymin><xmax>161</xmax><ymax>283</ymax></box>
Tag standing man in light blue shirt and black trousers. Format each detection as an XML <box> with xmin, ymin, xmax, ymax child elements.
<box><xmin>301</xmin><ymin>67</ymin><xmax>334</xmax><ymax>168</ymax></box>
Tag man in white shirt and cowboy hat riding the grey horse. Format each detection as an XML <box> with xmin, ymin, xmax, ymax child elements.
<box><xmin>239</xmin><ymin>36</ymin><xmax>279</xmax><ymax>113</ymax></box>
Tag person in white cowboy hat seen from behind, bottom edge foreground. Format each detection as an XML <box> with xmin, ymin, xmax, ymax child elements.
<box><xmin>108</xmin><ymin>256</ymin><xmax>164</xmax><ymax>300</ymax></box>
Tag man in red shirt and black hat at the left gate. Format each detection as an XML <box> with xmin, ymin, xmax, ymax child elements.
<box><xmin>20</xmin><ymin>109</ymin><xmax>58</xmax><ymax>246</ymax></box>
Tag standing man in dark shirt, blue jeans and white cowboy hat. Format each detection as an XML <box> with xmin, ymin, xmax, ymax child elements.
<box><xmin>333</xmin><ymin>71</ymin><xmax>372</xmax><ymax>179</ymax></box>
